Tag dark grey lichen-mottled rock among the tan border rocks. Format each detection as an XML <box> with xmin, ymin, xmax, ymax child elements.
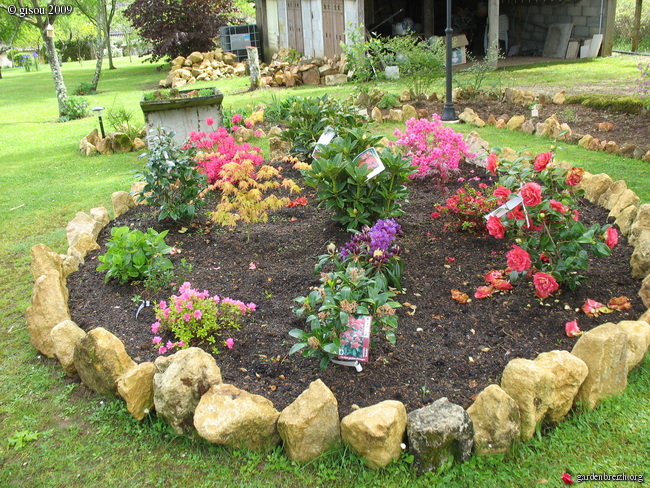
<box><xmin>407</xmin><ymin>397</ymin><xmax>474</xmax><ymax>474</ymax></box>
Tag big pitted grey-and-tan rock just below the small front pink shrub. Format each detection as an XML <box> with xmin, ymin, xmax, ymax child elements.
<box><xmin>153</xmin><ymin>347</ymin><xmax>221</xmax><ymax>434</ymax></box>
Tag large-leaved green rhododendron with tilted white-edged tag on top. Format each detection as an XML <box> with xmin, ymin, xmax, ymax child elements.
<box><xmin>302</xmin><ymin>130</ymin><xmax>415</xmax><ymax>230</ymax></box>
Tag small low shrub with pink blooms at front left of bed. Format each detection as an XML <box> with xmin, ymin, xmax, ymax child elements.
<box><xmin>151</xmin><ymin>282</ymin><xmax>257</xmax><ymax>354</ymax></box>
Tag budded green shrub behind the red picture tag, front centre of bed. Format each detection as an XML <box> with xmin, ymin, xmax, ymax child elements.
<box><xmin>289</xmin><ymin>266</ymin><xmax>401</xmax><ymax>369</ymax></box>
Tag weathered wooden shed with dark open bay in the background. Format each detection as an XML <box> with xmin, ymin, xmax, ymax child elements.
<box><xmin>251</xmin><ymin>0</ymin><xmax>616</xmax><ymax>59</ymax></box>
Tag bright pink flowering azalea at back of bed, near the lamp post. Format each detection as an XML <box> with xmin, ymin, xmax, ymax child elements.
<box><xmin>394</xmin><ymin>114</ymin><xmax>472</xmax><ymax>185</ymax></box>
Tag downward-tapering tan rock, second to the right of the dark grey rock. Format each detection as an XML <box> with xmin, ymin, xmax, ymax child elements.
<box><xmin>501</xmin><ymin>358</ymin><xmax>554</xmax><ymax>441</ymax></box>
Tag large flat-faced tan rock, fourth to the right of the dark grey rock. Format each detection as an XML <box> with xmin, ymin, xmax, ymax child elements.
<box><xmin>571</xmin><ymin>322</ymin><xmax>628</xmax><ymax>409</ymax></box>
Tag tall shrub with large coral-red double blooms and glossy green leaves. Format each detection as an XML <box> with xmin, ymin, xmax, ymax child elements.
<box><xmin>487</xmin><ymin>152</ymin><xmax>618</xmax><ymax>298</ymax></box>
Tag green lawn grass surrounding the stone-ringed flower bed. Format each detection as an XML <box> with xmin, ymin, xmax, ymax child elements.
<box><xmin>0</xmin><ymin>54</ymin><xmax>650</xmax><ymax>487</ymax></box>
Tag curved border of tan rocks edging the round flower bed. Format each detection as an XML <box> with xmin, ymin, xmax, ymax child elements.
<box><xmin>26</xmin><ymin>152</ymin><xmax>650</xmax><ymax>473</ymax></box>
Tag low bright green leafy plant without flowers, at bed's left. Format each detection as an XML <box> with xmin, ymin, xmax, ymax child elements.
<box><xmin>97</xmin><ymin>226</ymin><xmax>174</xmax><ymax>284</ymax></box>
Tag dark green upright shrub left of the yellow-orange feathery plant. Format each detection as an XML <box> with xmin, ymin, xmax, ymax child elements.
<box><xmin>137</xmin><ymin>129</ymin><xmax>207</xmax><ymax>221</ymax></box>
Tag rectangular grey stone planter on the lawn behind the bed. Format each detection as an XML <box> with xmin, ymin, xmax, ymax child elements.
<box><xmin>140</xmin><ymin>87</ymin><xmax>223</xmax><ymax>143</ymax></box>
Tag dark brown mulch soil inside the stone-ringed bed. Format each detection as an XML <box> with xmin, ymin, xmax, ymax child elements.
<box><xmin>68</xmin><ymin>159</ymin><xmax>644</xmax><ymax>415</ymax></box>
